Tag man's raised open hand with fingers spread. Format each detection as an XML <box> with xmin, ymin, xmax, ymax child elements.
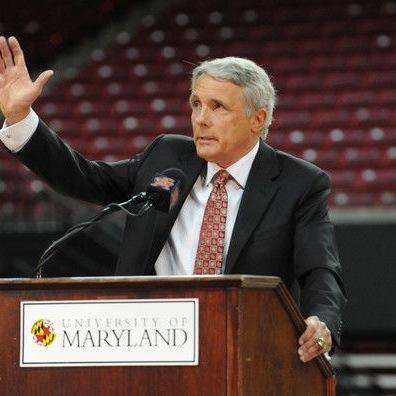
<box><xmin>0</xmin><ymin>36</ymin><xmax>54</xmax><ymax>125</ymax></box>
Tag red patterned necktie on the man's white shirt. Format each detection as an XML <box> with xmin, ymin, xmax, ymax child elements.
<box><xmin>194</xmin><ymin>169</ymin><xmax>231</xmax><ymax>274</ymax></box>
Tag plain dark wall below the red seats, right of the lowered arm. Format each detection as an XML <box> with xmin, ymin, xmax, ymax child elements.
<box><xmin>336</xmin><ymin>224</ymin><xmax>396</xmax><ymax>335</ymax></box>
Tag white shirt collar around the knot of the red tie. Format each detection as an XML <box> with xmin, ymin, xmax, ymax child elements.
<box><xmin>202</xmin><ymin>141</ymin><xmax>260</xmax><ymax>188</ymax></box>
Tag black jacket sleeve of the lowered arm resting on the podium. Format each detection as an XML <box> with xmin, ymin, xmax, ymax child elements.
<box><xmin>294</xmin><ymin>171</ymin><xmax>346</xmax><ymax>344</ymax></box>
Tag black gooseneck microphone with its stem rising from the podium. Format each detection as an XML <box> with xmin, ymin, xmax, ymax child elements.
<box><xmin>32</xmin><ymin>168</ymin><xmax>187</xmax><ymax>278</ymax></box>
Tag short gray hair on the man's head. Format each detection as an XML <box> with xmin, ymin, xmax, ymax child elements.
<box><xmin>191</xmin><ymin>56</ymin><xmax>276</xmax><ymax>139</ymax></box>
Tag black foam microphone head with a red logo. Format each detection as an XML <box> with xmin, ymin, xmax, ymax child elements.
<box><xmin>146</xmin><ymin>168</ymin><xmax>187</xmax><ymax>212</ymax></box>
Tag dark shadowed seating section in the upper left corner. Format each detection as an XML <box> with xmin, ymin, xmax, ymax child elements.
<box><xmin>0</xmin><ymin>0</ymin><xmax>133</xmax><ymax>68</ymax></box>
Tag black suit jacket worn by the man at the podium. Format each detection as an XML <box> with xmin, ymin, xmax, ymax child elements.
<box><xmin>16</xmin><ymin>122</ymin><xmax>345</xmax><ymax>343</ymax></box>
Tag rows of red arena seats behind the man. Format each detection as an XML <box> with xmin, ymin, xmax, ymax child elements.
<box><xmin>0</xmin><ymin>0</ymin><xmax>396</xmax><ymax>223</ymax></box>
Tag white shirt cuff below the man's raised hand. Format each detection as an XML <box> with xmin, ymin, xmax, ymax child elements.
<box><xmin>0</xmin><ymin>109</ymin><xmax>39</xmax><ymax>153</ymax></box>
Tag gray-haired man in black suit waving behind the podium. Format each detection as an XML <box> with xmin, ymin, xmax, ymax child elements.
<box><xmin>0</xmin><ymin>37</ymin><xmax>345</xmax><ymax>362</ymax></box>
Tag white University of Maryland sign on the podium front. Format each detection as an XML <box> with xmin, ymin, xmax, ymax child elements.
<box><xmin>20</xmin><ymin>298</ymin><xmax>198</xmax><ymax>367</ymax></box>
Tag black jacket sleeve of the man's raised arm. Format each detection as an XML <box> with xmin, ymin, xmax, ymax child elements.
<box><xmin>11</xmin><ymin>120</ymin><xmax>161</xmax><ymax>205</ymax></box>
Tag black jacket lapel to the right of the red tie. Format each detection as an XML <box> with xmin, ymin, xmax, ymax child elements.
<box><xmin>224</xmin><ymin>141</ymin><xmax>279</xmax><ymax>274</ymax></box>
